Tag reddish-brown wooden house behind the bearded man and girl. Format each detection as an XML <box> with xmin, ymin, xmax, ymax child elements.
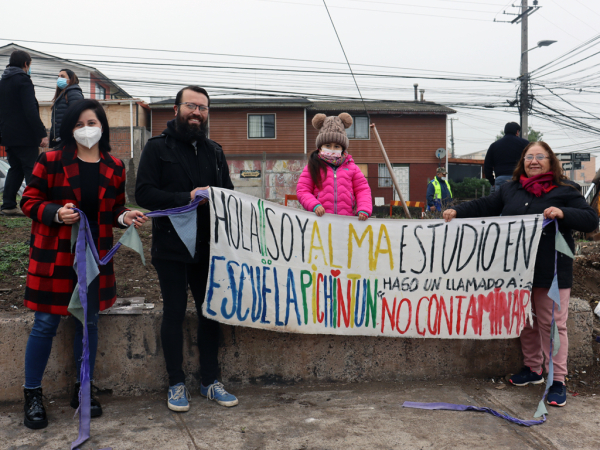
<box><xmin>150</xmin><ymin>98</ymin><xmax>456</xmax><ymax>204</ymax></box>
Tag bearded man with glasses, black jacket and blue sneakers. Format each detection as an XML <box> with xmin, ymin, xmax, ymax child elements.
<box><xmin>135</xmin><ymin>86</ymin><xmax>238</xmax><ymax>412</ymax></box>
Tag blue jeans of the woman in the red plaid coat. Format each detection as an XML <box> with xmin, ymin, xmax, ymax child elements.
<box><xmin>25</xmin><ymin>278</ymin><xmax>98</xmax><ymax>389</ymax></box>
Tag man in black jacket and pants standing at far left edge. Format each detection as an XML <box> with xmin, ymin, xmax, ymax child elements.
<box><xmin>0</xmin><ymin>50</ymin><xmax>48</xmax><ymax>216</ymax></box>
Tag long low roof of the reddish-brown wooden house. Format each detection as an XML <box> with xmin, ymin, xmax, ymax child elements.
<box><xmin>150</xmin><ymin>98</ymin><xmax>456</xmax><ymax>114</ymax></box>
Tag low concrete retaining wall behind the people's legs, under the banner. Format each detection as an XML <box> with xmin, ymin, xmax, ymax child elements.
<box><xmin>0</xmin><ymin>299</ymin><xmax>593</xmax><ymax>401</ymax></box>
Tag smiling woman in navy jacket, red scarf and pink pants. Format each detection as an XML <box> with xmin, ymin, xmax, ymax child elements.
<box><xmin>444</xmin><ymin>142</ymin><xmax>598</xmax><ymax>406</ymax></box>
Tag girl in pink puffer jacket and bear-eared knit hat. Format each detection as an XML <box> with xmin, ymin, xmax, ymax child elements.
<box><xmin>296</xmin><ymin>113</ymin><xmax>373</xmax><ymax>220</ymax></box>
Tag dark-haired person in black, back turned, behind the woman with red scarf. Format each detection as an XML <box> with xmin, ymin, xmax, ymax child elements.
<box><xmin>483</xmin><ymin>122</ymin><xmax>529</xmax><ymax>192</ymax></box>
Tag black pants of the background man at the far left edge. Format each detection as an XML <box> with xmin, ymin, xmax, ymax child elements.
<box><xmin>2</xmin><ymin>147</ymin><xmax>39</xmax><ymax>209</ymax></box>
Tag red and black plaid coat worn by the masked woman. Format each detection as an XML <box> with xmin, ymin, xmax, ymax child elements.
<box><xmin>21</xmin><ymin>150</ymin><xmax>127</xmax><ymax>315</ymax></box>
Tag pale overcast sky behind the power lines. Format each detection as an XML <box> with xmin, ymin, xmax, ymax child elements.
<box><xmin>0</xmin><ymin>0</ymin><xmax>600</xmax><ymax>160</ymax></box>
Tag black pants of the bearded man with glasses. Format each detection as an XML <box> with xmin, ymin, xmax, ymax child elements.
<box><xmin>152</xmin><ymin>253</ymin><xmax>219</xmax><ymax>386</ymax></box>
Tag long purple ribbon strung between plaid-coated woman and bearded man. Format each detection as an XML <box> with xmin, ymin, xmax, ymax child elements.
<box><xmin>71</xmin><ymin>190</ymin><xmax>208</xmax><ymax>450</ymax></box>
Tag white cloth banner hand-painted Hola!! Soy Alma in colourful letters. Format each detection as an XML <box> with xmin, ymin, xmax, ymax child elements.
<box><xmin>203</xmin><ymin>188</ymin><xmax>542</xmax><ymax>339</ymax></box>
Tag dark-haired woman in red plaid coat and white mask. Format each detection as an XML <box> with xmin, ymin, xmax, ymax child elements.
<box><xmin>21</xmin><ymin>100</ymin><xmax>147</xmax><ymax>429</ymax></box>
